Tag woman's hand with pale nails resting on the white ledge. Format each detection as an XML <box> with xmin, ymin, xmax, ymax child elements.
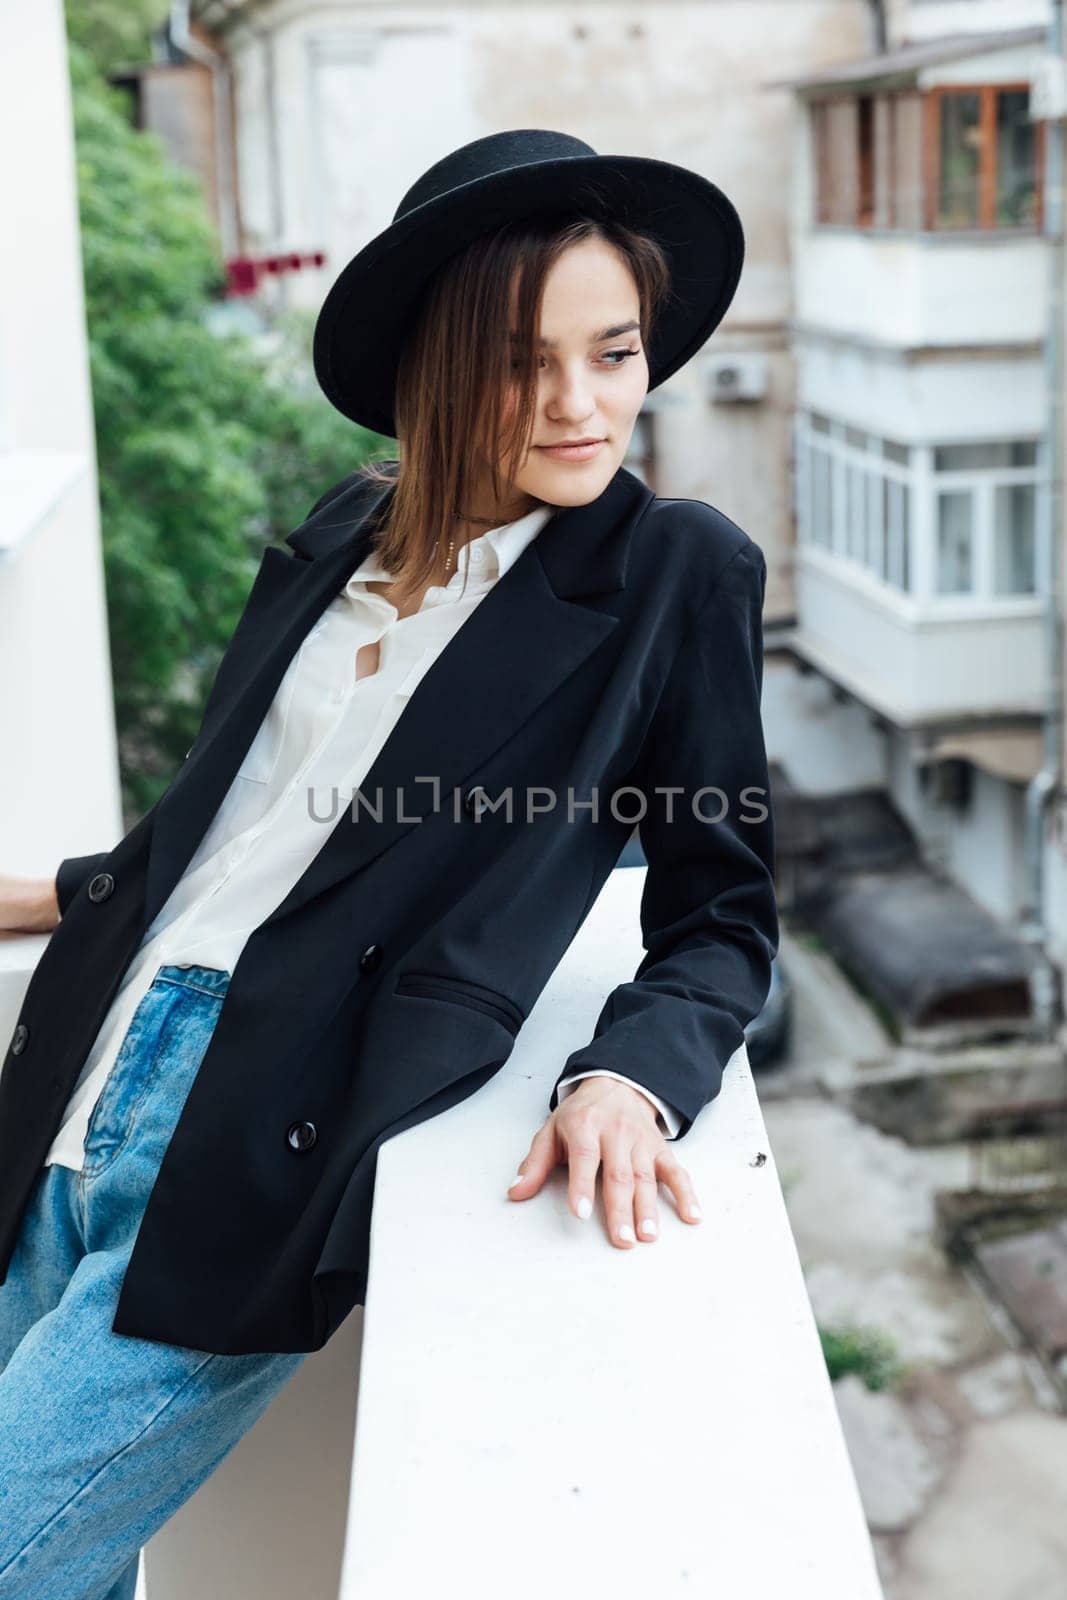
<box><xmin>507</xmin><ymin>1078</ymin><xmax>701</xmax><ymax>1250</ymax></box>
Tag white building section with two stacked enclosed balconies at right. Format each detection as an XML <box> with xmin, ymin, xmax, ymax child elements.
<box><xmin>767</xmin><ymin>0</ymin><xmax>1064</xmax><ymax>1011</ymax></box>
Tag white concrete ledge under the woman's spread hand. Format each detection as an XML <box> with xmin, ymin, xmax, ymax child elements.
<box><xmin>341</xmin><ymin>869</ymin><xmax>881</xmax><ymax>1600</ymax></box>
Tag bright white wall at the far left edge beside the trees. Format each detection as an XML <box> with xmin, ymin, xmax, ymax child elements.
<box><xmin>0</xmin><ymin>0</ymin><xmax>122</xmax><ymax>877</ymax></box>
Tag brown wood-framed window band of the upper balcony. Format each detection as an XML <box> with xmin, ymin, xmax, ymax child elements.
<box><xmin>809</xmin><ymin>83</ymin><xmax>1045</xmax><ymax>232</ymax></box>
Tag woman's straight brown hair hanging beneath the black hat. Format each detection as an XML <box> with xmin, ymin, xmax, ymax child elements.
<box><xmin>363</xmin><ymin>216</ymin><xmax>670</xmax><ymax>611</ymax></box>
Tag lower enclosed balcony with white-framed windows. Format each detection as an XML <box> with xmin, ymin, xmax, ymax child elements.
<box><xmin>792</xmin><ymin>419</ymin><xmax>1046</xmax><ymax>728</ymax></box>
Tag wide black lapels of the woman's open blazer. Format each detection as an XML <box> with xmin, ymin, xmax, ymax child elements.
<box><xmin>146</xmin><ymin>467</ymin><xmax>654</xmax><ymax>925</ymax></box>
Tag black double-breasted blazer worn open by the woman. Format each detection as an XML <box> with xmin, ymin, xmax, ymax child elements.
<box><xmin>0</xmin><ymin>467</ymin><xmax>777</xmax><ymax>1355</ymax></box>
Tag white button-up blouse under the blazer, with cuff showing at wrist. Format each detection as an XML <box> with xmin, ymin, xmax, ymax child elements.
<box><xmin>45</xmin><ymin>492</ymin><xmax>681</xmax><ymax>1171</ymax></box>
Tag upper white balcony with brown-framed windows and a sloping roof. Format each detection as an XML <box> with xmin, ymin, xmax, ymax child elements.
<box><xmin>768</xmin><ymin>38</ymin><xmax>1048</xmax><ymax>350</ymax></box>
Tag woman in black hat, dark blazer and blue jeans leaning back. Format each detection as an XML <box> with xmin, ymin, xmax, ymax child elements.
<box><xmin>0</xmin><ymin>130</ymin><xmax>777</xmax><ymax>1600</ymax></box>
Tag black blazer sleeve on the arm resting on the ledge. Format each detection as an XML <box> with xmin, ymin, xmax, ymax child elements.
<box><xmin>550</xmin><ymin>536</ymin><xmax>779</xmax><ymax>1138</ymax></box>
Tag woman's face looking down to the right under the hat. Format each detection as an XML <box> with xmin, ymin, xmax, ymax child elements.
<box><xmin>476</xmin><ymin>238</ymin><xmax>648</xmax><ymax>515</ymax></box>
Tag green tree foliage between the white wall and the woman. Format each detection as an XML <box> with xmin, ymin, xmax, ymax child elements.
<box><xmin>67</xmin><ymin>21</ymin><xmax>386</xmax><ymax>824</ymax></box>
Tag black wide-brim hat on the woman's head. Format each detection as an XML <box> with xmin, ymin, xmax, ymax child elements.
<box><xmin>314</xmin><ymin>128</ymin><xmax>744</xmax><ymax>438</ymax></box>
